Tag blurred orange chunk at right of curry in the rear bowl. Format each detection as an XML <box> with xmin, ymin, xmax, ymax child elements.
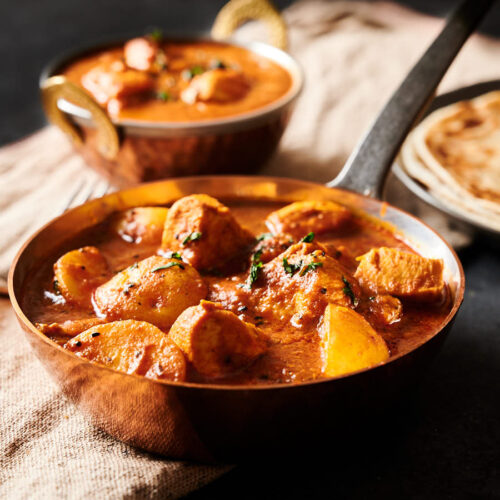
<box><xmin>181</xmin><ymin>69</ymin><xmax>250</xmax><ymax>104</ymax></box>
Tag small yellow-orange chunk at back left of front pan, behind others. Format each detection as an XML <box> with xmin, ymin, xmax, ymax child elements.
<box><xmin>112</xmin><ymin>207</ymin><xmax>168</xmax><ymax>245</ymax></box>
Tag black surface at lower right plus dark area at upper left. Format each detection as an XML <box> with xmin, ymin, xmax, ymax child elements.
<box><xmin>0</xmin><ymin>0</ymin><xmax>500</xmax><ymax>500</ymax></box>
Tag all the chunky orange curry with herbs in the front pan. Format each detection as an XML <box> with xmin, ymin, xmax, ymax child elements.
<box><xmin>24</xmin><ymin>194</ymin><xmax>451</xmax><ymax>385</ymax></box>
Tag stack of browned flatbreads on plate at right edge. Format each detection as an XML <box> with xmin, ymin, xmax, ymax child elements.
<box><xmin>399</xmin><ymin>91</ymin><xmax>500</xmax><ymax>231</ymax></box>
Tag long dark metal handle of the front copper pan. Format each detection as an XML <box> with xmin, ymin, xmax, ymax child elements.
<box><xmin>327</xmin><ymin>0</ymin><xmax>493</xmax><ymax>198</ymax></box>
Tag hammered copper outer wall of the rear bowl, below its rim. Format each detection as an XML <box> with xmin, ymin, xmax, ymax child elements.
<box><xmin>75</xmin><ymin>112</ymin><xmax>288</xmax><ymax>187</ymax></box>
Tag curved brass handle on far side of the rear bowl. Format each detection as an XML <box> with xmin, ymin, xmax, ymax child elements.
<box><xmin>212</xmin><ymin>0</ymin><xmax>288</xmax><ymax>50</ymax></box>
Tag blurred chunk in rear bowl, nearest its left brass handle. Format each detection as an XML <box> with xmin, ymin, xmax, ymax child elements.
<box><xmin>81</xmin><ymin>61</ymin><xmax>155</xmax><ymax>109</ymax></box>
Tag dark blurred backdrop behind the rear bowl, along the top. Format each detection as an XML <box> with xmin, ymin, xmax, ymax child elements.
<box><xmin>0</xmin><ymin>0</ymin><xmax>500</xmax><ymax>145</ymax></box>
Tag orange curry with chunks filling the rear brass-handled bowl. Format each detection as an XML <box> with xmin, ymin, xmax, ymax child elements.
<box><xmin>63</xmin><ymin>32</ymin><xmax>292</xmax><ymax>122</ymax></box>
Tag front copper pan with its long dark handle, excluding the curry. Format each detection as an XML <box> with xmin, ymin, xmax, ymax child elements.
<box><xmin>9</xmin><ymin>0</ymin><xmax>491</xmax><ymax>461</ymax></box>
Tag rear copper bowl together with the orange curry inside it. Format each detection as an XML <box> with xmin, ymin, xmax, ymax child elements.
<box><xmin>40</xmin><ymin>2</ymin><xmax>303</xmax><ymax>186</ymax></box>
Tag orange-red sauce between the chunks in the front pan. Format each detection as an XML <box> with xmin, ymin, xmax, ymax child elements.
<box><xmin>23</xmin><ymin>200</ymin><xmax>451</xmax><ymax>384</ymax></box>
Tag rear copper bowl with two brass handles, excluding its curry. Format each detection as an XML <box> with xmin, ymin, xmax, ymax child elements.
<box><xmin>40</xmin><ymin>0</ymin><xmax>303</xmax><ymax>187</ymax></box>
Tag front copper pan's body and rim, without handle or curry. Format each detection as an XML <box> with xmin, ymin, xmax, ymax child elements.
<box><xmin>9</xmin><ymin>177</ymin><xmax>464</xmax><ymax>462</ymax></box>
